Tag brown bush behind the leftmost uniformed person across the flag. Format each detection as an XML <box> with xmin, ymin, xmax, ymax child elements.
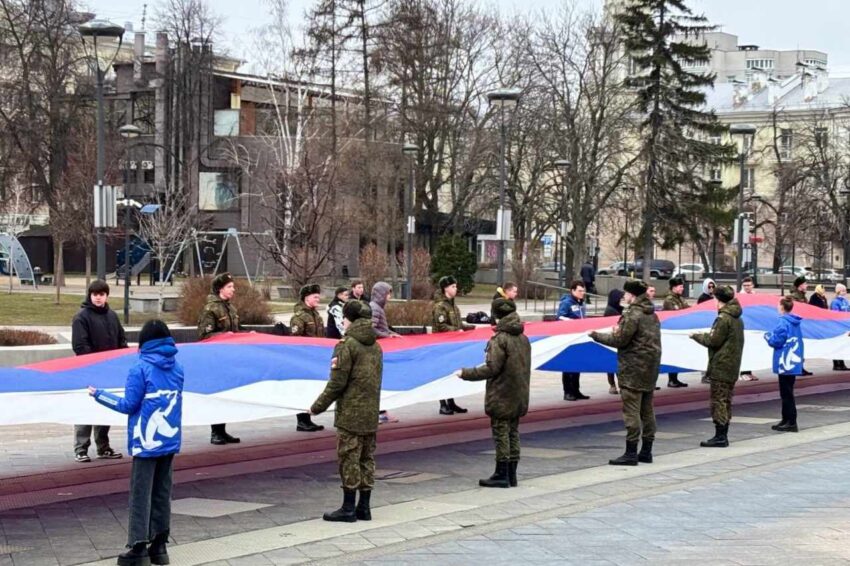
<box><xmin>177</xmin><ymin>277</ymin><xmax>274</xmax><ymax>326</ymax></box>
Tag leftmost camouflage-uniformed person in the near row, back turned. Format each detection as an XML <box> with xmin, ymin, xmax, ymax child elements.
<box><xmin>310</xmin><ymin>300</ymin><xmax>384</xmax><ymax>523</ymax></box>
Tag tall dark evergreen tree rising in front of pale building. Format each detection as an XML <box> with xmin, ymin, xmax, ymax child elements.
<box><xmin>616</xmin><ymin>0</ymin><xmax>734</xmax><ymax>278</ymax></box>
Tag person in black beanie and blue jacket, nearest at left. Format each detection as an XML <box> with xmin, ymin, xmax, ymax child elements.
<box><xmin>89</xmin><ymin>320</ymin><xmax>183</xmax><ymax>566</ymax></box>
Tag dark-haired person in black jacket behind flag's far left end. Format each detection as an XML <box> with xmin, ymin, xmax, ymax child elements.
<box><xmin>71</xmin><ymin>279</ymin><xmax>127</xmax><ymax>463</ymax></box>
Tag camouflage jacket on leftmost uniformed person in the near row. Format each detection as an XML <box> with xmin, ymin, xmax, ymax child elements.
<box><xmin>310</xmin><ymin>318</ymin><xmax>384</xmax><ymax>434</ymax></box>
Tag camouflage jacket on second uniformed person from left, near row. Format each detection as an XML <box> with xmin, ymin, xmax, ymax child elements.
<box><xmin>460</xmin><ymin>312</ymin><xmax>531</xmax><ymax>419</ymax></box>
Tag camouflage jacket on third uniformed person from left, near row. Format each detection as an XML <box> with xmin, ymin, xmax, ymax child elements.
<box><xmin>590</xmin><ymin>295</ymin><xmax>661</xmax><ymax>391</ymax></box>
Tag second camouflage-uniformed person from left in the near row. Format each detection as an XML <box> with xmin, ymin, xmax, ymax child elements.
<box><xmin>458</xmin><ymin>299</ymin><xmax>531</xmax><ymax>487</ymax></box>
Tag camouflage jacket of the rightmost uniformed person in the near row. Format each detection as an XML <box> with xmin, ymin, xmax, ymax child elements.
<box><xmin>693</xmin><ymin>299</ymin><xmax>744</xmax><ymax>383</ymax></box>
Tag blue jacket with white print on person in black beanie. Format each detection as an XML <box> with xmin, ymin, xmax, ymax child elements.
<box><xmin>94</xmin><ymin>338</ymin><xmax>183</xmax><ymax>458</ymax></box>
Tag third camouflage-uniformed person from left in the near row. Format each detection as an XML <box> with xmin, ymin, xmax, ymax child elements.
<box><xmin>590</xmin><ymin>279</ymin><xmax>661</xmax><ymax>466</ymax></box>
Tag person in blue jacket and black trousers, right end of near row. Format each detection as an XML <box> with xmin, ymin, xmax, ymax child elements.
<box><xmin>764</xmin><ymin>296</ymin><xmax>805</xmax><ymax>432</ymax></box>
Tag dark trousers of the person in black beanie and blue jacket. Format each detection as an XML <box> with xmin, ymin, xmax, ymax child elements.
<box><xmin>127</xmin><ymin>454</ymin><xmax>174</xmax><ymax>547</ymax></box>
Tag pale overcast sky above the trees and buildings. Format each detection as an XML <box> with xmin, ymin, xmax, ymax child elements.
<box><xmin>79</xmin><ymin>0</ymin><xmax>850</xmax><ymax>75</ymax></box>
